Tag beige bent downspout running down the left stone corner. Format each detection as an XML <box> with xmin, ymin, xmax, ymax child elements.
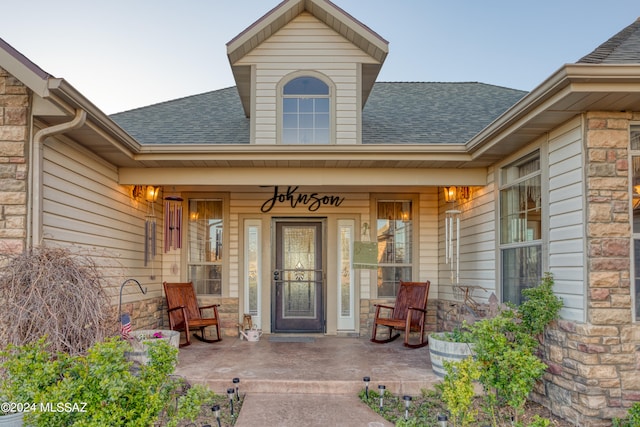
<box><xmin>27</xmin><ymin>109</ymin><xmax>87</xmax><ymax>247</ymax></box>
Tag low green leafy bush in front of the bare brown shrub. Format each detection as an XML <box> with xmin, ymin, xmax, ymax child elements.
<box><xmin>0</xmin><ymin>338</ymin><xmax>213</xmax><ymax>427</ymax></box>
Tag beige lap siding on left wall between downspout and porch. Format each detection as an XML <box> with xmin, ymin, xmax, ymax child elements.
<box><xmin>42</xmin><ymin>139</ymin><xmax>162</xmax><ymax>302</ymax></box>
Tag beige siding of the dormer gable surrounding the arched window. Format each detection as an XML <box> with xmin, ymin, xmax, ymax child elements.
<box><xmin>237</xmin><ymin>13</ymin><xmax>375</xmax><ymax>144</ymax></box>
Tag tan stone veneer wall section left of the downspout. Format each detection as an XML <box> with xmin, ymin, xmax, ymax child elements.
<box><xmin>0</xmin><ymin>68</ymin><xmax>29</xmax><ymax>253</ymax></box>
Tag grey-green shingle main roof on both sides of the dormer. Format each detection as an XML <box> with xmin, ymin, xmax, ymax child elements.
<box><xmin>111</xmin><ymin>83</ymin><xmax>526</xmax><ymax>144</ymax></box>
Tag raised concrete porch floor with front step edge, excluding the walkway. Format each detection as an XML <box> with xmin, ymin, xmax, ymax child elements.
<box><xmin>176</xmin><ymin>334</ymin><xmax>440</xmax><ymax>396</ymax></box>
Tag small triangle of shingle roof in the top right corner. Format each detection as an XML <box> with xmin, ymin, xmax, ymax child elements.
<box><xmin>577</xmin><ymin>18</ymin><xmax>640</xmax><ymax>64</ymax></box>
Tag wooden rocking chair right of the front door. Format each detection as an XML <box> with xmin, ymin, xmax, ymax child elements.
<box><xmin>371</xmin><ymin>281</ymin><xmax>431</xmax><ymax>348</ymax></box>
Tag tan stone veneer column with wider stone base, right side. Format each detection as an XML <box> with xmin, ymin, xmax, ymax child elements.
<box><xmin>536</xmin><ymin>112</ymin><xmax>640</xmax><ymax>427</ymax></box>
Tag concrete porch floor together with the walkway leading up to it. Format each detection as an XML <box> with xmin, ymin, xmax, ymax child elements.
<box><xmin>176</xmin><ymin>335</ymin><xmax>440</xmax><ymax>427</ymax></box>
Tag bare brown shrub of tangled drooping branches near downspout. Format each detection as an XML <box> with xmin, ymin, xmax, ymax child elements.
<box><xmin>0</xmin><ymin>246</ymin><xmax>113</xmax><ymax>355</ymax></box>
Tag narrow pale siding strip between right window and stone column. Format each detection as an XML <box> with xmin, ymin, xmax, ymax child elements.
<box><xmin>549</xmin><ymin>118</ymin><xmax>585</xmax><ymax>321</ymax></box>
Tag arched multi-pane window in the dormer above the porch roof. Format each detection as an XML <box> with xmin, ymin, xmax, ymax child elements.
<box><xmin>282</xmin><ymin>76</ymin><xmax>331</xmax><ymax>144</ymax></box>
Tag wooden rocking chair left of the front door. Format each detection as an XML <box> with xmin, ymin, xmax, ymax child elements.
<box><xmin>162</xmin><ymin>282</ymin><xmax>222</xmax><ymax>347</ymax></box>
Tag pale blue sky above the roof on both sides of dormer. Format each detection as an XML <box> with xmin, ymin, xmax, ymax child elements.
<box><xmin>0</xmin><ymin>0</ymin><xmax>640</xmax><ymax>114</ymax></box>
